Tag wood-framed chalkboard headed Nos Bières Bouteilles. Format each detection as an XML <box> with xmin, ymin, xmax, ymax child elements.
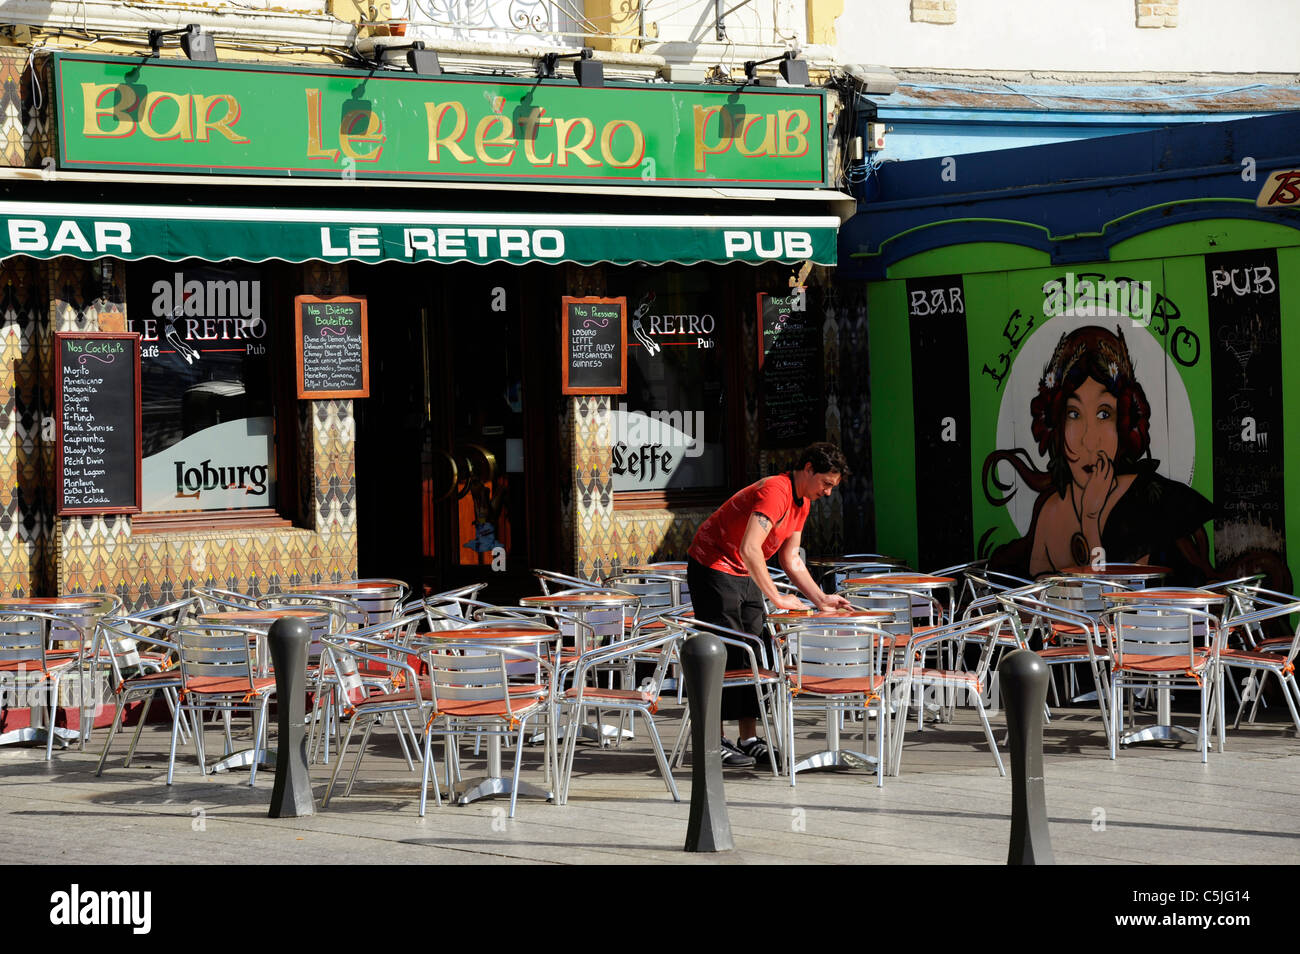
<box><xmin>294</xmin><ymin>295</ymin><xmax>371</xmax><ymax>398</ymax></box>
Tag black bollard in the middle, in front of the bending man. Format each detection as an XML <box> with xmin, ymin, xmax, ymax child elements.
<box><xmin>680</xmin><ymin>633</ymin><xmax>736</xmax><ymax>851</ymax></box>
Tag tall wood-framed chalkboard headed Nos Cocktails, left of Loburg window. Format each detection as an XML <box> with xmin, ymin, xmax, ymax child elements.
<box><xmin>55</xmin><ymin>331</ymin><xmax>140</xmax><ymax>513</ymax></box>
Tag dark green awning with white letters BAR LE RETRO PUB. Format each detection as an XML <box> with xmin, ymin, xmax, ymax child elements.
<box><xmin>0</xmin><ymin>201</ymin><xmax>840</xmax><ymax>265</ymax></box>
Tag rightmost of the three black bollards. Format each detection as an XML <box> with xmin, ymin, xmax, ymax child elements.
<box><xmin>997</xmin><ymin>650</ymin><xmax>1056</xmax><ymax>864</ymax></box>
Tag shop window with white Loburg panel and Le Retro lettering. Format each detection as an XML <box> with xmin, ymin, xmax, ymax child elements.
<box><xmin>127</xmin><ymin>261</ymin><xmax>283</xmax><ymax>528</ymax></box>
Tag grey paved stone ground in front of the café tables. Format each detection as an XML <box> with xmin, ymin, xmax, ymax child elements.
<box><xmin>0</xmin><ymin>706</ymin><xmax>1300</xmax><ymax>864</ymax></box>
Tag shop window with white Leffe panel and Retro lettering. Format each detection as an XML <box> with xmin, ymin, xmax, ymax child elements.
<box><xmin>610</xmin><ymin>268</ymin><xmax>740</xmax><ymax>507</ymax></box>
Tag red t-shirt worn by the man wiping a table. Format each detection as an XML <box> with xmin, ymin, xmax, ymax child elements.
<box><xmin>689</xmin><ymin>473</ymin><xmax>813</xmax><ymax>576</ymax></box>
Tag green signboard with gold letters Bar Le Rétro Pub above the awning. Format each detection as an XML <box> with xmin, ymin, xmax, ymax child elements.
<box><xmin>55</xmin><ymin>55</ymin><xmax>827</xmax><ymax>187</ymax></box>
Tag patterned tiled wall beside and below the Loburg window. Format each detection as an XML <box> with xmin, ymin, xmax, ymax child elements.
<box><xmin>41</xmin><ymin>259</ymin><xmax>356</xmax><ymax>607</ymax></box>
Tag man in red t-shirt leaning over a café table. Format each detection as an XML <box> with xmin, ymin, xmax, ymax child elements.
<box><xmin>686</xmin><ymin>442</ymin><xmax>850</xmax><ymax>768</ymax></box>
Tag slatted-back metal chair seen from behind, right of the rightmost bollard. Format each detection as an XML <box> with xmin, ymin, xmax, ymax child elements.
<box><xmin>1101</xmin><ymin>603</ymin><xmax>1223</xmax><ymax>762</ymax></box>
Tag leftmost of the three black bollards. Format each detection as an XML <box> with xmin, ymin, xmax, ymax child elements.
<box><xmin>267</xmin><ymin>617</ymin><xmax>316</xmax><ymax>819</ymax></box>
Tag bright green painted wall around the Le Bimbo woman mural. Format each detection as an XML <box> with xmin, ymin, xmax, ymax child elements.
<box><xmin>868</xmin><ymin>220</ymin><xmax>1300</xmax><ymax>587</ymax></box>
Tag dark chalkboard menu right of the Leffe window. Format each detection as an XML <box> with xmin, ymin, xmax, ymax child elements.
<box><xmin>758</xmin><ymin>289</ymin><xmax>826</xmax><ymax>447</ymax></box>
